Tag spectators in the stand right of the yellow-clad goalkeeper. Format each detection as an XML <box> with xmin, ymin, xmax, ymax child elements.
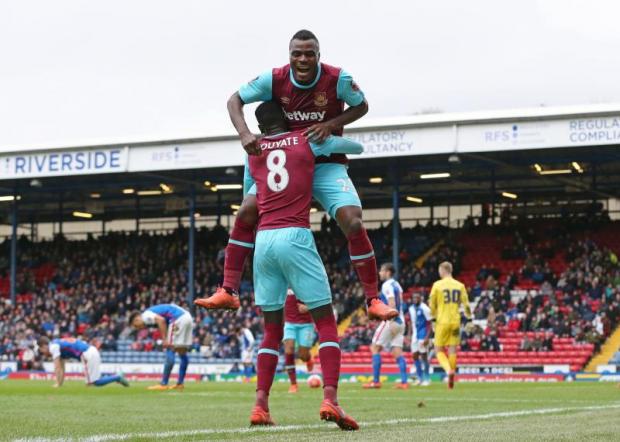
<box><xmin>464</xmin><ymin>223</ymin><xmax>620</xmax><ymax>351</ymax></box>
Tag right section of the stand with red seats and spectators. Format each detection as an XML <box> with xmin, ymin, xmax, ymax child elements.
<box><xmin>334</xmin><ymin>218</ymin><xmax>620</xmax><ymax>372</ymax></box>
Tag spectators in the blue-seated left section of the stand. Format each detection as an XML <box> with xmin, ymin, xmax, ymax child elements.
<box><xmin>0</xmin><ymin>220</ymin><xmax>439</xmax><ymax>360</ymax></box>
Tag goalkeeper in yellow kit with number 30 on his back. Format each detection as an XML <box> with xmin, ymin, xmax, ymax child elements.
<box><xmin>430</xmin><ymin>261</ymin><xmax>471</xmax><ymax>389</ymax></box>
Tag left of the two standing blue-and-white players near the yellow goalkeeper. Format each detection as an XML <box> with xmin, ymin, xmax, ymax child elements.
<box><xmin>363</xmin><ymin>263</ymin><xmax>409</xmax><ymax>390</ymax></box>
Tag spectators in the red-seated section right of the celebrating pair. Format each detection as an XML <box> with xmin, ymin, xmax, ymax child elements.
<box><xmin>344</xmin><ymin>219</ymin><xmax>620</xmax><ymax>358</ymax></box>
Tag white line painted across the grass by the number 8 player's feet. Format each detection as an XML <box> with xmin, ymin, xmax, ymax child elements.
<box><xmin>15</xmin><ymin>403</ymin><xmax>620</xmax><ymax>442</ymax></box>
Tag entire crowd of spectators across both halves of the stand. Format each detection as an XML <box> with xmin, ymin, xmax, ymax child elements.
<box><xmin>0</xmin><ymin>216</ymin><xmax>620</xmax><ymax>360</ymax></box>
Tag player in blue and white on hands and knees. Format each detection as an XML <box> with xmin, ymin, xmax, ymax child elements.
<box><xmin>37</xmin><ymin>336</ymin><xmax>129</xmax><ymax>387</ymax></box>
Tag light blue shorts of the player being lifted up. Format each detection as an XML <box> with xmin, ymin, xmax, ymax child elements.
<box><xmin>243</xmin><ymin>163</ymin><xmax>362</xmax><ymax>218</ymax></box>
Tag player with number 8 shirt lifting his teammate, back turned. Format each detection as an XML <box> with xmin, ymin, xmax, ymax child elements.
<box><xmin>248</xmin><ymin>101</ymin><xmax>362</xmax><ymax>430</ymax></box>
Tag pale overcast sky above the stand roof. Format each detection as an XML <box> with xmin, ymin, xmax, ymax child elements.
<box><xmin>0</xmin><ymin>0</ymin><xmax>620</xmax><ymax>149</ymax></box>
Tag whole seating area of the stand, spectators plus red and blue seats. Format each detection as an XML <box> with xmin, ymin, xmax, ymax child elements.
<box><xmin>0</xmin><ymin>214</ymin><xmax>620</xmax><ymax>372</ymax></box>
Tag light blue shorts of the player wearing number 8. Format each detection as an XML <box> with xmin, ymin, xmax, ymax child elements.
<box><xmin>254</xmin><ymin>227</ymin><xmax>332</xmax><ymax>311</ymax></box>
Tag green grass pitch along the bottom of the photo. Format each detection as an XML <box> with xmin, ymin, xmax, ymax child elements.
<box><xmin>0</xmin><ymin>381</ymin><xmax>620</xmax><ymax>442</ymax></box>
